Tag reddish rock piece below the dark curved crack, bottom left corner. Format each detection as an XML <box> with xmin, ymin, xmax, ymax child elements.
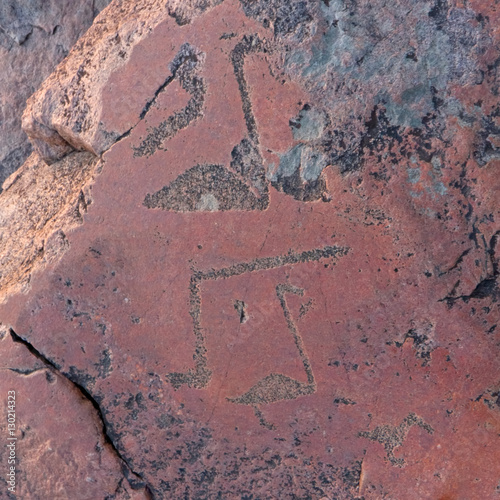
<box><xmin>0</xmin><ymin>325</ymin><xmax>147</xmax><ymax>500</ymax></box>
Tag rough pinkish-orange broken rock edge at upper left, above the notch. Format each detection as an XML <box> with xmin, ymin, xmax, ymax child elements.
<box><xmin>23</xmin><ymin>0</ymin><xmax>221</xmax><ymax>163</ymax></box>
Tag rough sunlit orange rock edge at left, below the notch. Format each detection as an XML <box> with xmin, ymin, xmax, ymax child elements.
<box><xmin>0</xmin><ymin>153</ymin><xmax>97</xmax><ymax>302</ymax></box>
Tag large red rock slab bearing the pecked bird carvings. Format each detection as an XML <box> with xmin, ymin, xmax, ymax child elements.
<box><xmin>0</xmin><ymin>0</ymin><xmax>500</xmax><ymax>499</ymax></box>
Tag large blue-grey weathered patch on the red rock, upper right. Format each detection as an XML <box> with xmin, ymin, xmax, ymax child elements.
<box><xmin>284</xmin><ymin>0</ymin><xmax>491</xmax><ymax>139</ymax></box>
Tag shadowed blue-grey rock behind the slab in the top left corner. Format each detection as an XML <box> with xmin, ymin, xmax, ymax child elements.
<box><xmin>0</xmin><ymin>0</ymin><xmax>109</xmax><ymax>191</ymax></box>
